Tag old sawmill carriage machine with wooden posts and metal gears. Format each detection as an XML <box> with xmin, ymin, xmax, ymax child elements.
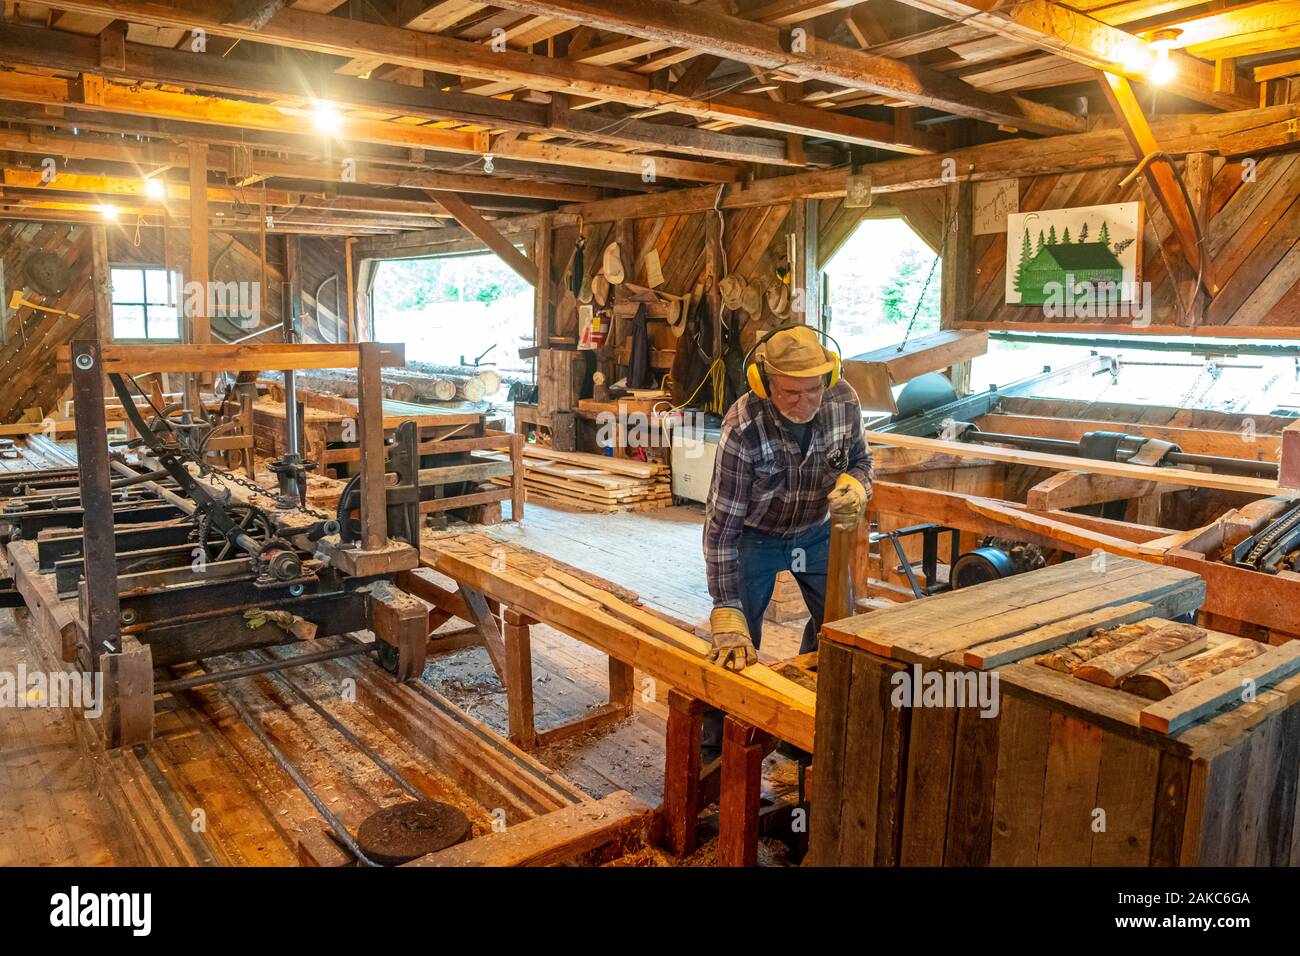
<box><xmin>0</xmin><ymin>342</ymin><xmax>428</xmax><ymax>745</ymax></box>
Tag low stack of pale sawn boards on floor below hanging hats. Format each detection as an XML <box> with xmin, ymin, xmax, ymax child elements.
<box><xmin>493</xmin><ymin>445</ymin><xmax>672</xmax><ymax>514</ymax></box>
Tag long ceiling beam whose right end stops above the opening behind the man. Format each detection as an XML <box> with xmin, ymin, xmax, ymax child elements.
<box><xmin>27</xmin><ymin>0</ymin><xmax>935</xmax><ymax>149</ymax></box>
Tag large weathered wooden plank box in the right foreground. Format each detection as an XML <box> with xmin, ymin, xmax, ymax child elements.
<box><xmin>810</xmin><ymin>557</ymin><xmax>1300</xmax><ymax>866</ymax></box>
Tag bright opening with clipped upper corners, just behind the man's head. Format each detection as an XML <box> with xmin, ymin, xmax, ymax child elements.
<box><xmin>826</xmin><ymin>219</ymin><xmax>943</xmax><ymax>358</ymax></box>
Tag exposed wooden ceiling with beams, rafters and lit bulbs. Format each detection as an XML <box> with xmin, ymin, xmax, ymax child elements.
<box><xmin>0</xmin><ymin>0</ymin><xmax>1300</xmax><ymax>234</ymax></box>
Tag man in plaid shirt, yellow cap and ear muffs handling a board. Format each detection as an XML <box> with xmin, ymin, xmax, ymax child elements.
<box><xmin>705</xmin><ymin>326</ymin><xmax>874</xmax><ymax>670</ymax></box>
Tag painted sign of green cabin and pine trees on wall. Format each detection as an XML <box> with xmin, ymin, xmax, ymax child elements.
<box><xmin>1006</xmin><ymin>203</ymin><xmax>1143</xmax><ymax>306</ymax></box>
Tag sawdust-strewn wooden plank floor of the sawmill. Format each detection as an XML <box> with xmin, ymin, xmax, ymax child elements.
<box><xmin>0</xmin><ymin>506</ymin><xmax>800</xmax><ymax>865</ymax></box>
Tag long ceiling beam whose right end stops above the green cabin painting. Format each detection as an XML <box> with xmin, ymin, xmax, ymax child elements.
<box><xmin>483</xmin><ymin>0</ymin><xmax>1084</xmax><ymax>133</ymax></box>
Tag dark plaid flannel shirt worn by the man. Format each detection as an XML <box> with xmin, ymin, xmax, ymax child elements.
<box><xmin>705</xmin><ymin>381</ymin><xmax>875</xmax><ymax>607</ymax></box>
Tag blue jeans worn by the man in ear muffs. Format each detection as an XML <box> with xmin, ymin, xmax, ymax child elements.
<box><xmin>701</xmin><ymin>522</ymin><xmax>831</xmax><ymax>748</ymax></box>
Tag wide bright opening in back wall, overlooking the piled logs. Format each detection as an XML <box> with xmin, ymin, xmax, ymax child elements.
<box><xmin>371</xmin><ymin>252</ymin><xmax>533</xmax><ymax>381</ymax></box>
